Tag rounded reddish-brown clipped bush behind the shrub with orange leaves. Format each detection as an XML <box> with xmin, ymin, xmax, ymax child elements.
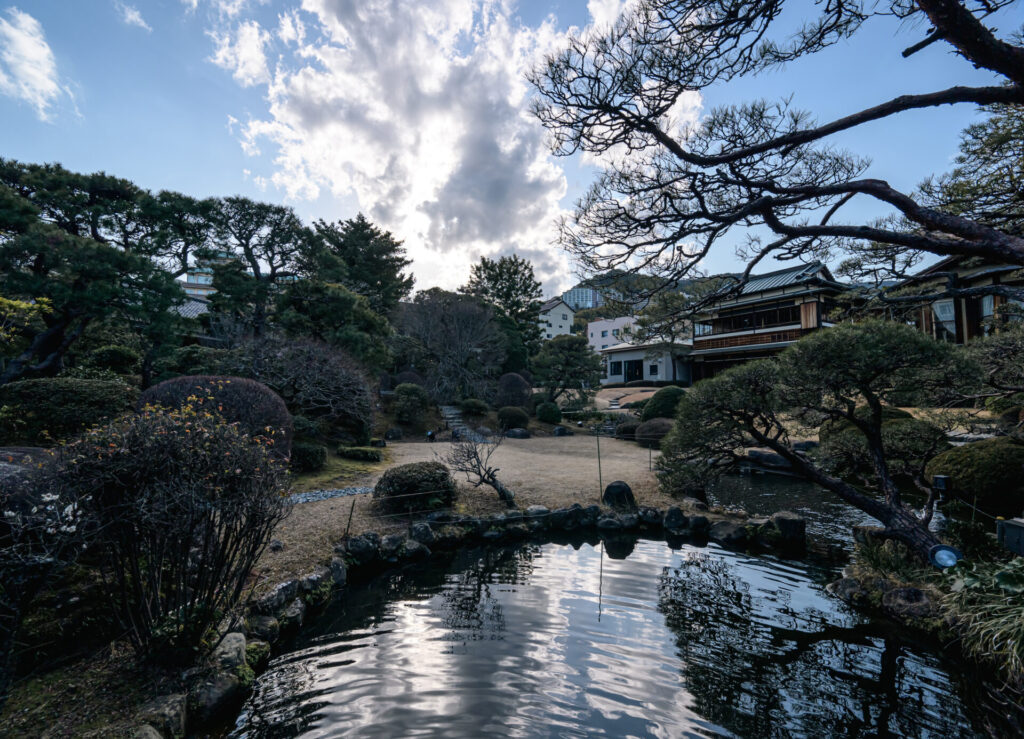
<box><xmin>138</xmin><ymin>375</ymin><xmax>293</xmax><ymax>459</ymax></box>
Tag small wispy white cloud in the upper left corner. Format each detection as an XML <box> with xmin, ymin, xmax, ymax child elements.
<box><xmin>0</xmin><ymin>7</ymin><xmax>65</xmax><ymax>121</ymax></box>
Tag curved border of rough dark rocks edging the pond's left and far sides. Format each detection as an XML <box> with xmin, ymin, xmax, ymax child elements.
<box><xmin>134</xmin><ymin>498</ymin><xmax>807</xmax><ymax>739</ymax></box>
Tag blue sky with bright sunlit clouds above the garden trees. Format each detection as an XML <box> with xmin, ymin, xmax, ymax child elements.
<box><xmin>0</xmin><ymin>0</ymin><xmax>1024</xmax><ymax>296</ymax></box>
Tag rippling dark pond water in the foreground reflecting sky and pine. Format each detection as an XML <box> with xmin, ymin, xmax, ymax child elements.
<box><xmin>231</xmin><ymin>540</ymin><xmax>999</xmax><ymax>737</ymax></box>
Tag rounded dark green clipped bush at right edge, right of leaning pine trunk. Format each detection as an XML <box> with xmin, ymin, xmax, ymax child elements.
<box><xmin>925</xmin><ymin>436</ymin><xmax>1024</xmax><ymax>516</ymax></box>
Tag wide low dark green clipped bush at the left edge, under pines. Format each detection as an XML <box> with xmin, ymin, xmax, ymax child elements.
<box><xmin>0</xmin><ymin>378</ymin><xmax>138</xmax><ymax>446</ymax></box>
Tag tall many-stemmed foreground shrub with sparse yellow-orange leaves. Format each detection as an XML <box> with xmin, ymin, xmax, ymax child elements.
<box><xmin>25</xmin><ymin>405</ymin><xmax>288</xmax><ymax>661</ymax></box>
